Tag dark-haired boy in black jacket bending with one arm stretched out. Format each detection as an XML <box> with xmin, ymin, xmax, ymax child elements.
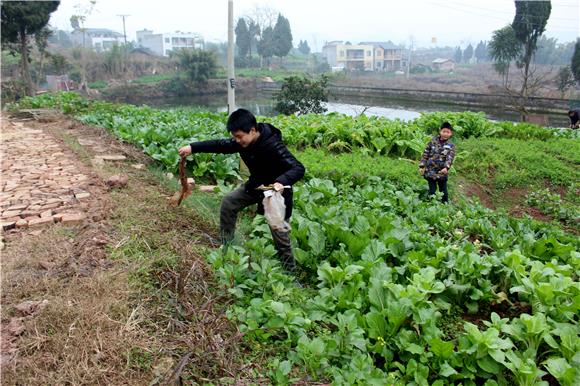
<box><xmin>179</xmin><ymin>109</ymin><xmax>305</xmax><ymax>271</ymax></box>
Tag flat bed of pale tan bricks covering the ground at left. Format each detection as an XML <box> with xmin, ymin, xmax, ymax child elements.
<box><xmin>0</xmin><ymin>119</ymin><xmax>90</xmax><ymax>230</ymax></box>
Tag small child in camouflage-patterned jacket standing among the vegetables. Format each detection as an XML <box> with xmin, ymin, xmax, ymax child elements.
<box><xmin>419</xmin><ymin>122</ymin><xmax>455</xmax><ymax>203</ymax></box>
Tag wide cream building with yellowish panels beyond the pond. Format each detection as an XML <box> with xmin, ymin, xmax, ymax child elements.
<box><xmin>322</xmin><ymin>41</ymin><xmax>405</xmax><ymax>71</ymax></box>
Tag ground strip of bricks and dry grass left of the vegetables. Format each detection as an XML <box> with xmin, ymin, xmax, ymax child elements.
<box><xmin>1</xmin><ymin>113</ymin><xmax>254</xmax><ymax>385</ymax></box>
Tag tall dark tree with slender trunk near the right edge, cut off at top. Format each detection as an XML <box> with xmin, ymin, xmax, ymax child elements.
<box><xmin>512</xmin><ymin>0</ymin><xmax>552</xmax><ymax>120</ymax></box>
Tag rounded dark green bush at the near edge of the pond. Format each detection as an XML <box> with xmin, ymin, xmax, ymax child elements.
<box><xmin>274</xmin><ymin>75</ymin><xmax>328</xmax><ymax>115</ymax></box>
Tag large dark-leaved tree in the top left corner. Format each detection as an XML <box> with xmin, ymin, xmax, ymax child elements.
<box><xmin>1</xmin><ymin>1</ymin><xmax>60</xmax><ymax>95</ymax></box>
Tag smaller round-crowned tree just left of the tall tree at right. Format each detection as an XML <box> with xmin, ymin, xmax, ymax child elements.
<box><xmin>489</xmin><ymin>25</ymin><xmax>522</xmax><ymax>87</ymax></box>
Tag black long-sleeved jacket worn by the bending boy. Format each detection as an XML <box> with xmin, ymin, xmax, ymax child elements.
<box><xmin>191</xmin><ymin>123</ymin><xmax>305</xmax><ymax>219</ymax></box>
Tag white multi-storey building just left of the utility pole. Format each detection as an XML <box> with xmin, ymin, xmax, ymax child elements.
<box><xmin>137</xmin><ymin>29</ymin><xmax>204</xmax><ymax>56</ymax></box>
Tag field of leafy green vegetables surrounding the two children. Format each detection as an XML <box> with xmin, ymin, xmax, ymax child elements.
<box><xmin>10</xmin><ymin>93</ymin><xmax>580</xmax><ymax>386</ymax></box>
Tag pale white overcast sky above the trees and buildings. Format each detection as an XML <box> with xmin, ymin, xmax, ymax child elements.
<box><xmin>50</xmin><ymin>0</ymin><xmax>580</xmax><ymax>51</ymax></box>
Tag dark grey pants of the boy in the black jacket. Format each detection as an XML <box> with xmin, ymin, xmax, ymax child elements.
<box><xmin>220</xmin><ymin>187</ymin><xmax>296</xmax><ymax>271</ymax></box>
